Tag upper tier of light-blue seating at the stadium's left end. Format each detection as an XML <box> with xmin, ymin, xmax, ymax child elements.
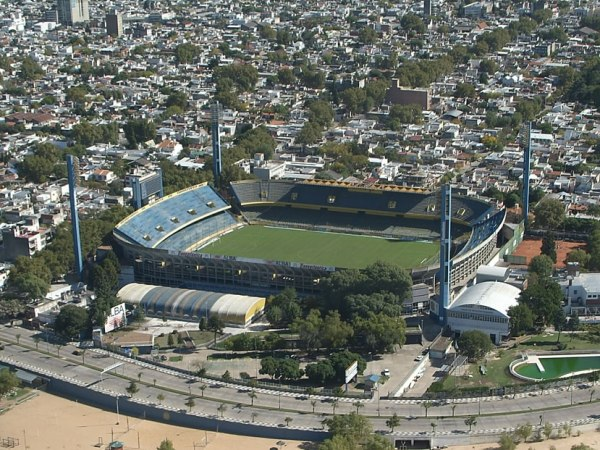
<box><xmin>115</xmin><ymin>183</ymin><xmax>230</xmax><ymax>248</ymax></box>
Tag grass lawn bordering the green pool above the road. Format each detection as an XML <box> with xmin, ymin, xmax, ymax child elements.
<box><xmin>444</xmin><ymin>333</ymin><xmax>598</xmax><ymax>390</ymax></box>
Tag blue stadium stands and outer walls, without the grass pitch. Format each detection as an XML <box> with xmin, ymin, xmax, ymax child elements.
<box><xmin>113</xmin><ymin>180</ymin><xmax>505</xmax><ymax>295</ymax></box>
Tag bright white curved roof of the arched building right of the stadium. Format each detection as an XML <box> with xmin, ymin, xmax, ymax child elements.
<box><xmin>448</xmin><ymin>281</ymin><xmax>521</xmax><ymax>318</ymax></box>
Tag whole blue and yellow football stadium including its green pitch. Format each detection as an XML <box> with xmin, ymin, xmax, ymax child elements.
<box><xmin>113</xmin><ymin>180</ymin><xmax>505</xmax><ymax>295</ymax></box>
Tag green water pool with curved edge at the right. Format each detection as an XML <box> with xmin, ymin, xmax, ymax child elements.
<box><xmin>515</xmin><ymin>355</ymin><xmax>600</xmax><ymax>380</ymax></box>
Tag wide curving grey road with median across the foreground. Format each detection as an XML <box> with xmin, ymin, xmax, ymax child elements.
<box><xmin>0</xmin><ymin>327</ymin><xmax>600</xmax><ymax>442</ymax></box>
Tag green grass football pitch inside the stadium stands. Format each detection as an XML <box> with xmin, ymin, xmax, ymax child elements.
<box><xmin>199</xmin><ymin>225</ymin><xmax>439</xmax><ymax>269</ymax></box>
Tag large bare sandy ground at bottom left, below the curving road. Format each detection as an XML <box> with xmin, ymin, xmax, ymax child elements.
<box><xmin>0</xmin><ymin>392</ymin><xmax>306</xmax><ymax>450</ymax></box>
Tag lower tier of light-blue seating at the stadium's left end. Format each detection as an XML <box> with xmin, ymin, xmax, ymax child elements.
<box><xmin>156</xmin><ymin>211</ymin><xmax>238</xmax><ymax>251</ymax></box>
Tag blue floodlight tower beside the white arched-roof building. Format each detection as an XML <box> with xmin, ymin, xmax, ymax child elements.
<box><xmin>438</xmin><ymin>184</ymin><xmax>452</xmax><ymax>324</ymax></box>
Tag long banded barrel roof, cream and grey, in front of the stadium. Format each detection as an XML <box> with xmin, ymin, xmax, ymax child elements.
<box><xmin>117</xmin><ymin>283</ymin><xmax>265</xmax><ymax>326</ymax></box>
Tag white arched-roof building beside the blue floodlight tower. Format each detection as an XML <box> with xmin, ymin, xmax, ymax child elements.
<box><xmin>447</xmin><ymin>281</ymin><xmax>521</xmax><ymax>344</ymax></box>
